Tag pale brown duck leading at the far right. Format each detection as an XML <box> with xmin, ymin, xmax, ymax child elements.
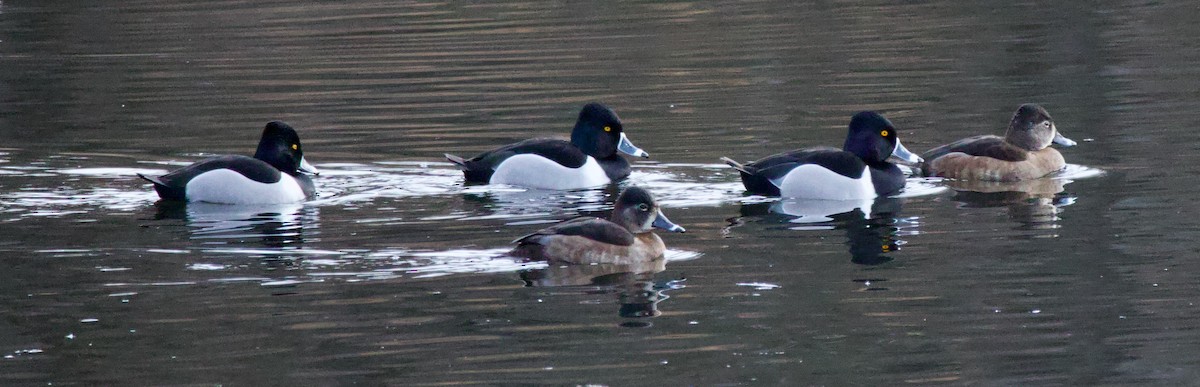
<box><xmin>920</xmin><ymin>103</ymin><xmax>1076</xmax><ymax>181</ymax></box>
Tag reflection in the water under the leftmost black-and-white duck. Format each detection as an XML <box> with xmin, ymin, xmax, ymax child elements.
<box><xmin>155</xmin><ymin>201</ymin><xmax>319</xmax><ymax>248</ymax></box>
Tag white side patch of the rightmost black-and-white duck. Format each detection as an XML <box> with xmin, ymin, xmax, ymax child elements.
<box><xmin>770</xmin><ymin>163</ymin><xmax>875</xmax><ymax>201</ymax></box>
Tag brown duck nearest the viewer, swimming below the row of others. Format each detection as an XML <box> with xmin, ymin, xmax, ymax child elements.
<box><xmin>510</xmin><ymin>186</ymin><xmax>686</xmax><ymax>264</ymax></box>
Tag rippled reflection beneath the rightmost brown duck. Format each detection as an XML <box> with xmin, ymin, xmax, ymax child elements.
<box><xmin>946</xmin><ymin>179</ymin><xmax>1075</xmax><ymax>230</ymax></box>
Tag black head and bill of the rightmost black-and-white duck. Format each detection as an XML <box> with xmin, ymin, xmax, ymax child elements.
<box><xmin>841</xmin><ymin>112</ymin><xmax>920</xmax><ymax>165</ymax></box>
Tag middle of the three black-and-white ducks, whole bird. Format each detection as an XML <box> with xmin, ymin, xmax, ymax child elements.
<box><xmin>445</xmin><ymin>102</ymin><xmax>650</xmax><ymax>190</ymax></box>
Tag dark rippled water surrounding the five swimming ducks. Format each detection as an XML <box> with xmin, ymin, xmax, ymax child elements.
<box><xmin>0</xmin><ymin>0</ymin><xmax>1200</xmax><ymax>385</ymax></box>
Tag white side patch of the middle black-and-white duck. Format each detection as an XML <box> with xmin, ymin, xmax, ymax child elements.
<box><xmin>490</xmin><ymin>154</ymin><xmax>611</xmax><ymax>190</ymax></box>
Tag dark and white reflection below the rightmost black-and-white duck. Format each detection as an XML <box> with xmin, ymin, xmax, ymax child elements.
<box><xmin>740</xmin><ymin>197</ymin><xmax>904</xmax><ymax>266</ymax></box>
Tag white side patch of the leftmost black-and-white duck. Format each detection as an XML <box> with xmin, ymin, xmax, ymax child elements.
<box><xmin>186</xmin><ymin>169</ymin><xmax>306</xmax><ymax>204</ymax></box>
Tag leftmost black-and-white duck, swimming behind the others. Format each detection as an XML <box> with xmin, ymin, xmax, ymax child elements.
<box><xmin>138</xmin><ymin>121</ymin><xmax>319</xmax><ymax>204</ymax></box>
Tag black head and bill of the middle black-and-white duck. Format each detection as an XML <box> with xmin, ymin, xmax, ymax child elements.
<box><xmin>571</xmin><ymin>102</ymin><xmax>650</xmax><ymax>159</ymax></box>
